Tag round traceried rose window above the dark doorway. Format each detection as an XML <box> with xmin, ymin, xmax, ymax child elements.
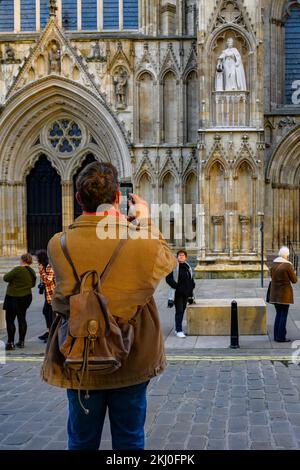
<box><xmin>48</xmin><ymin>119</ymin><xmax>82</xmax><ymax>153</ymax></box>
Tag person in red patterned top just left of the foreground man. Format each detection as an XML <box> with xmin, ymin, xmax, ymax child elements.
<box><xmin>36</xmin><ymin>250</ymin><xmax>55</xmax><ymax>343</ymax></box>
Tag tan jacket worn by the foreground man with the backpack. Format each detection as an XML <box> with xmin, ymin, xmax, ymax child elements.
<box><xmin>42</xmin><ymin>216</ymin><xmax>176</xmax><ymax>390</ymax></box>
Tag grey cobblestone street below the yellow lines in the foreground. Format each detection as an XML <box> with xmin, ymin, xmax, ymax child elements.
<box><xmin>0</xmin><ymin>358</ymin><xmax>300</xmax><ymax>450</ymax></box>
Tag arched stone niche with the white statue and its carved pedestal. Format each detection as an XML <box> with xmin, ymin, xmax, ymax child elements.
<box><xmin>211</xmin><ymin>29</ymin><xmax>250</xmax><ymax>127</ymax></box>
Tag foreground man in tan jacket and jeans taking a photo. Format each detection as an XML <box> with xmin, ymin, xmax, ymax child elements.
<box><xmin>42</xmin><ymin>162</ymin><xmax>176</xmax><ymax>450</ymax></box>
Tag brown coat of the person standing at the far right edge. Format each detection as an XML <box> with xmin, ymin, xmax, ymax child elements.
<box><xmin>270</xmin><ymin>258</ymin><xmax>298</xmax><ymax>305</ymax></box>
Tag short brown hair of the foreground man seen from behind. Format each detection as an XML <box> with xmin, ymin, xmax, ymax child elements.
<box><xmin>76</xmin><ymin>162</ymin><xmax>119</xmax><ymax>212</ymax></box>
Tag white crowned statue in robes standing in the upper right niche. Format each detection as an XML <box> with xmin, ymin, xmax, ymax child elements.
<box><xmin>216</xmin><ymin>38</ymin><xmax>247</xmax><ymax>91</ymax></box>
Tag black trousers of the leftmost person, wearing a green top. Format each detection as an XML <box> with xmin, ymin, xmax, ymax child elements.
<box><xmin>4</xmin><ymin>294</ymin><xmax>32</xmax><ymax>343</ymax></box>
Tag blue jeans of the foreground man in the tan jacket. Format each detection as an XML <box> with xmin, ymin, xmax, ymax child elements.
<box><xmin>67</xmin><ymin>381</ymin><xmax>149</xmax><ymax>450</ymax></box>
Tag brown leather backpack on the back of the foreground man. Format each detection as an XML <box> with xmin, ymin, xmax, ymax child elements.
<box><xmin>58</xmin><ymin>234</ymin><xmax>134</xmax><ymax>390</ymax></box>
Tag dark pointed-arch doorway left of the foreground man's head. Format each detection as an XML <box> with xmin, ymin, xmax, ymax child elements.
<box><xmin>26</xmin><ymin>155</ymin><xmax>62</xmax><ymax>253</ymax></box>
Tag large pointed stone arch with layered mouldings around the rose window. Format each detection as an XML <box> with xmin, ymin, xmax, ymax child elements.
<box><xmin>0</xmin><ymin>76</ymin><xmax>131</xmax><ymax>181</ymax></box>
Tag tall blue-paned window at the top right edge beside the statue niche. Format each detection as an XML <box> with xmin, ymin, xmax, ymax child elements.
<box><xmin>285</xmin><ymin>1</ymin><xmax>300</xmax><ymax>104</ymax></box>
